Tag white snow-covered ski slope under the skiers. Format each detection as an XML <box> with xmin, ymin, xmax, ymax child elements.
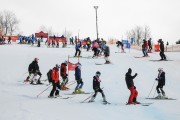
<box><xmin>0</xmin><ymin>44</ymin><xmax>180</xmax><ymax>120</ymax></box>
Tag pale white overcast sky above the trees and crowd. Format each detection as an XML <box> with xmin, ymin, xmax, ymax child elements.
<box><xmin>0</xmin><ymin>0</ymin><xmax>180</xmax><ymax>43</ymax></box>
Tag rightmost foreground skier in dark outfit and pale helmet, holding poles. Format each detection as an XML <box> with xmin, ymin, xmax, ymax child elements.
<box><xmin>155</xmin><ymin>68</ymin><xmax>167</xmax><ymax>99</ymax></box>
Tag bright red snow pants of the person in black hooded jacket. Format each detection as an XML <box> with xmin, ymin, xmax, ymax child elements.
<box><xmin>128</xmin><ymin>86</ymin><xmax>138</xmax><ymax>103</ymax></box>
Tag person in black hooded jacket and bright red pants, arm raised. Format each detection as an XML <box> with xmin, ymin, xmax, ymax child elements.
<box><xmin>125</xmin><ymin>68</ymin><xmax>140</xmax><ymax>104</ymax></box>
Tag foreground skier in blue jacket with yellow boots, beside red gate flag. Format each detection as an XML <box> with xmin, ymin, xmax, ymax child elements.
<box><xmin>73</xmin><ymin>63</ymin><xmax>84</xmax><ymax>94</ymax></box>
